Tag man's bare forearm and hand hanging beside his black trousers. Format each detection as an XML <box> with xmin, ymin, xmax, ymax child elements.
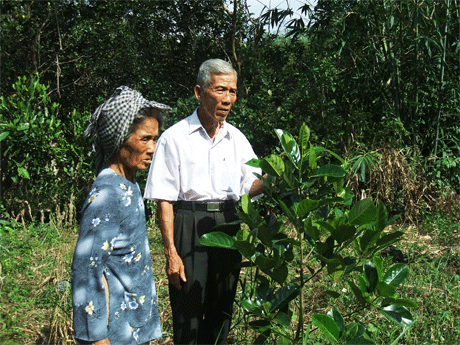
<box><xmin>158</xmin><ymin>200</ymin><xmax>187</xmax><ymax>290</ymax></box>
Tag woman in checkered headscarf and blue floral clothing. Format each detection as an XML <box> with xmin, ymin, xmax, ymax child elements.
<box><xmin>72</xmin><ymin>86</ymin><xmax>170</xmax><ymax>345</ymax></box>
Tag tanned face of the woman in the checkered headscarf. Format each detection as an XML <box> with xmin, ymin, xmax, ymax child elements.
<box><xmin>110</xmin><ymin>117</ymin><xmax>159</xmax><ymax>180</ymax></box>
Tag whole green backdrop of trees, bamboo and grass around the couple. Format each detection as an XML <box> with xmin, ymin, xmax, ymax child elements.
<box><xmin>0</xmin><ymin>0</ymin><xmax>460</xmax><ymax>344</ymax></box>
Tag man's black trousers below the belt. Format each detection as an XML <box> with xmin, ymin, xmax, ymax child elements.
<box><xmin>169</xmin><ymin>209</ymin><xmax>241</xmax><ymax>345</ymax></box>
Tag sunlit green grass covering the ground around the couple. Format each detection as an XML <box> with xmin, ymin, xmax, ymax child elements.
<box><xmin>0</xmin><ymin>217</ymin><xmax>460</xmax><ymax>345</ymax></box>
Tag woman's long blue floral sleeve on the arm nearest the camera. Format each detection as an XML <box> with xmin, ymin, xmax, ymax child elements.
<box><xmin>72</xmin><ymin>186</ymin><xmax>120</xmax><ymax>341</ymax></box>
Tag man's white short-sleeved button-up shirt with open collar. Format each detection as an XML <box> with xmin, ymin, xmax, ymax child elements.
<box><xmin>144</xmin><ymin>110</ymin><xmax>261</xmax><ymax>201</ymax></box>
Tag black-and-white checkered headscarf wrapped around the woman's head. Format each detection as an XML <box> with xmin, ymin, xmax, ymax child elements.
<box><xmin>85</xmin><ymin>86</ymin><xmax>171</xmax><ymax>175</ymax></box>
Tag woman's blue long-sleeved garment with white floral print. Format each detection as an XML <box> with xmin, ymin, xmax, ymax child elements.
<box><xmin>72</xmin><ymin>168</ymin><xmax>162</xmax><ymax>345</ymax></box>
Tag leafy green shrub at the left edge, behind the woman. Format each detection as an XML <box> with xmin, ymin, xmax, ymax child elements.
<box><xmin>0</xmin><ymin>76</ymin><xmax>91</xmax><ymax>223</ymax></box>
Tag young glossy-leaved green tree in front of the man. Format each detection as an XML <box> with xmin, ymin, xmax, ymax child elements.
<box><xmin>200</xmin><ymin>125</ymin><xmax>417</xmax><ymax>344</ymax></box>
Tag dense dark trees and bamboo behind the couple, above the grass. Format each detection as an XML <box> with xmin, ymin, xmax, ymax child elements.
<box><xmin>0</xmin><ymin>0</ymin><xmax>460</xmax><ymax>223</ymax></box>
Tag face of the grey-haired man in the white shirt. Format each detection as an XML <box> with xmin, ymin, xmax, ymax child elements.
<box><xmin>195</xmin><ymin>73</ymin><xmax>236</xmax><ymax>122</ymax></box>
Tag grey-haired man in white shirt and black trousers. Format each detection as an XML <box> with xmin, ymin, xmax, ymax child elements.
<box><xmin>145</xmin><ymin>59</ymin><xmax>263</xmax><ymax>344</ymax></box>
